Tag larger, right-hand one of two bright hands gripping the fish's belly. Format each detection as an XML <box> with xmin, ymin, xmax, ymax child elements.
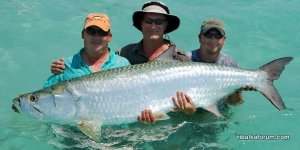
<box><xmin>172</xmin><ymin>92</ymin><xmax>196</xmax><ymax>115</ymax></box>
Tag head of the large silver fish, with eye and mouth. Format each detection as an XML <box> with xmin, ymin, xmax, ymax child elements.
<box><xmin>12</xmin><ymin>87</ymin><xmax>76</xmax><ymax>121</ymax></box>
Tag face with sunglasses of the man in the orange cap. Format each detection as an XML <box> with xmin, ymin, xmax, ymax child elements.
<box><xmin>82</xmin><ymin>26</ymin><xmax>112</xmax><ymax>52</ymax></box>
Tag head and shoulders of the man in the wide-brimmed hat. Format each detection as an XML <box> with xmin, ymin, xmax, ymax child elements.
<box><xmin>119</xmin><ymin>1</ymin><xmax>190</xmax><ymax>65</ymax></box>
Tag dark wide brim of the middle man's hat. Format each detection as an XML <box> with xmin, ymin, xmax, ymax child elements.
<box><xmin>132</xmin><ymin>11</ymin><xmax>180</xmax><ymax>33</ymax></box>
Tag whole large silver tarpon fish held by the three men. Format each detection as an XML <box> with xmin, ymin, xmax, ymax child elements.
<box><xmin>13</xmin><ymin>57</ymin><xmax>293</xmax><ymax>140</ymax></box>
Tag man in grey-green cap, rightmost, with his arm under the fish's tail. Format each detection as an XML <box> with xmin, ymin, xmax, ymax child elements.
<box><xmin>188</xmin><ymin>18</ymin><xmax>255</xmax><ymax>104</ymax></box>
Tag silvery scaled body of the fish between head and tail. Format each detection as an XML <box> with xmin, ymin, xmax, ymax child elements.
<box><xmin>61</xmin><ymin>62</ymin><xmax>267</xmax><ymax>124</ymax></box>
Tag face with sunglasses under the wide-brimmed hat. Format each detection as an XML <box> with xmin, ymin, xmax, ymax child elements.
<box><xmin>141</xmin><ymin>13</ymin><xmax>168</xmax><ymax>40</ymax></box>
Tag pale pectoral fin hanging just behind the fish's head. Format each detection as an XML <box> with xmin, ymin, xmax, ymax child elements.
<box><xmin>76</xmin><ymin>120</ymin><xmax>102</xmax><ymax>142</ymax></box>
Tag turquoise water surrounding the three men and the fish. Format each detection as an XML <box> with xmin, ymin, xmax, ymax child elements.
<box><xmin>0</xmin><ymin>0</ymin><xmax>300</xmax><ymax>150</ymax></box>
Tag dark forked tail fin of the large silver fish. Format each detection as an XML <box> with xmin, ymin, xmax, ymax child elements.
<box><xmin>257</xmin><ymin>57</ymin><xmax>293</xmax><ymax>110</ymax></box>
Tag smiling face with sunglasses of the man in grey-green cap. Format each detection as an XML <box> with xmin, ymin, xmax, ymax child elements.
<box><xmin>199</xmin><ymin>29</ymin><xmax>226</xmax><ymax>54</ymax></box>
